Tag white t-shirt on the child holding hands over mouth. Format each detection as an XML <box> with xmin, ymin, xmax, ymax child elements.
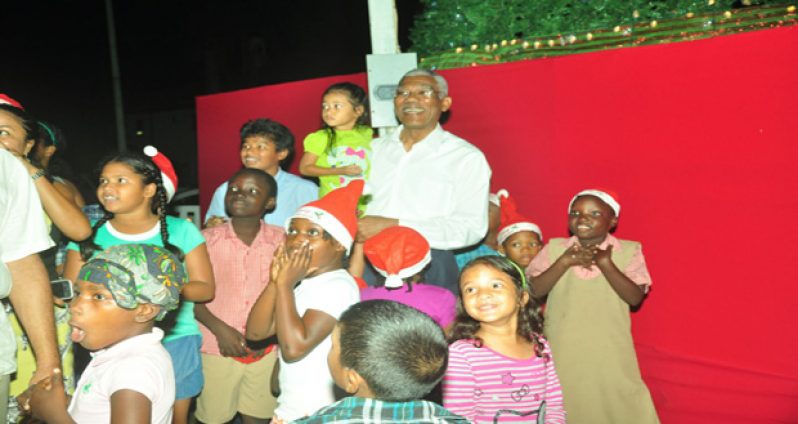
<box><xmin>274</xmin><ymin>269</ymin><xmax>360</xmax><ymax>422</ymax></box>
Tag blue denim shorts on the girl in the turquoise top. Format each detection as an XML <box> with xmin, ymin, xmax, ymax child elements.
<box><xmin>163</xmin><ymin>335</ymin><xmax>204</xmax><ymax>400</ymax></box>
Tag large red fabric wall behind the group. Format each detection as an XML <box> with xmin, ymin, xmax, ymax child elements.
<box><xmin>197</xmin><ymin>27</ymin><xmax>798</xmax><ymax>424</ymax></box>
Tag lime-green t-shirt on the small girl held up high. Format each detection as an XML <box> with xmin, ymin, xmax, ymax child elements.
<box><xmin>304</xmin><ymin>126</ymin><xmax>373</xmax><ymax>197</ymax></box>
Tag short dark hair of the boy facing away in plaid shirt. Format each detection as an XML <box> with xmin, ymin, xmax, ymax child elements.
<box><xmin>338</xmin><ymin>300</ymin><xmax>449</xmax><ymax>402</ymax></box>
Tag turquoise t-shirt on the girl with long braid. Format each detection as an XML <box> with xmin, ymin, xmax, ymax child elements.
<box><xmin>67</xmin><ymin>216</ymin><xmax>205</xmax><ymax>341</ymax></box>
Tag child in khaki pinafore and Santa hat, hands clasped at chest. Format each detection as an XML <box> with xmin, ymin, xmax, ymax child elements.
<box><xmin>527</xmin><ymin>190</ymin><xmax>659</xmax><ymax>424</ymax></box>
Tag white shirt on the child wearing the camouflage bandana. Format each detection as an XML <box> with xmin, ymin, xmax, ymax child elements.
<box><xmin>69</xmin><ymin>328</ymin><xmax>175</xmax><ymax>424</ymax></box>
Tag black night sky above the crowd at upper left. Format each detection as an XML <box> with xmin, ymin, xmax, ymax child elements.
<box><xmin>0</xmin><ymin>0</ymin><xmax>421</xmax><ymax>194</ymax></box>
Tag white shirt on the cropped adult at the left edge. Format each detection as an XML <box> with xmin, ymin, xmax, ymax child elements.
<box><xmin>0</xmin><ymin>148</ymin><xmax>53</xmax><ymax>375</ymax></box>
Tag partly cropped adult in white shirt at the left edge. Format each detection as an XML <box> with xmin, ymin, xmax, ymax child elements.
<box><xmin>0</xmin><ymin>148</ymin><xmax>60</xmax><ymax>420</ymax></box>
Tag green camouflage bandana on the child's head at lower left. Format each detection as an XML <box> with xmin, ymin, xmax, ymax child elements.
<box><xmin>79</xmin><ymin>244</ymin><xmax>188</xmax><ymax>321</ymax></box>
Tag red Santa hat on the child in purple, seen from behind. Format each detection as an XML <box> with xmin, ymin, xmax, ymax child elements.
<box><xmin>363</xmin><ymin>225</ymin><xmax>432</xmax><ymax>289</ymax></box>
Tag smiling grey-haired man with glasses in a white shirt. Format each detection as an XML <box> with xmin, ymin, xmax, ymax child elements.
<box><xmin>358</xmin><ymin>69</ymin><xmax>491</xmax><ymax>294</ymax></box>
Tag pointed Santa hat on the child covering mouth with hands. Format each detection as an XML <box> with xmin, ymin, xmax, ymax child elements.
<box><xmin>285</xmin><ymin>180</ymin><xmax>364</xmax><ymax>255</ymax></box>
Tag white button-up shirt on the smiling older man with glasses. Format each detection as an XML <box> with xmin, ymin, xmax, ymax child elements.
<box><xmin>366</xmin><ymin>125</ymin><xmax>491</xmax><ymax>250</ymax></box>
